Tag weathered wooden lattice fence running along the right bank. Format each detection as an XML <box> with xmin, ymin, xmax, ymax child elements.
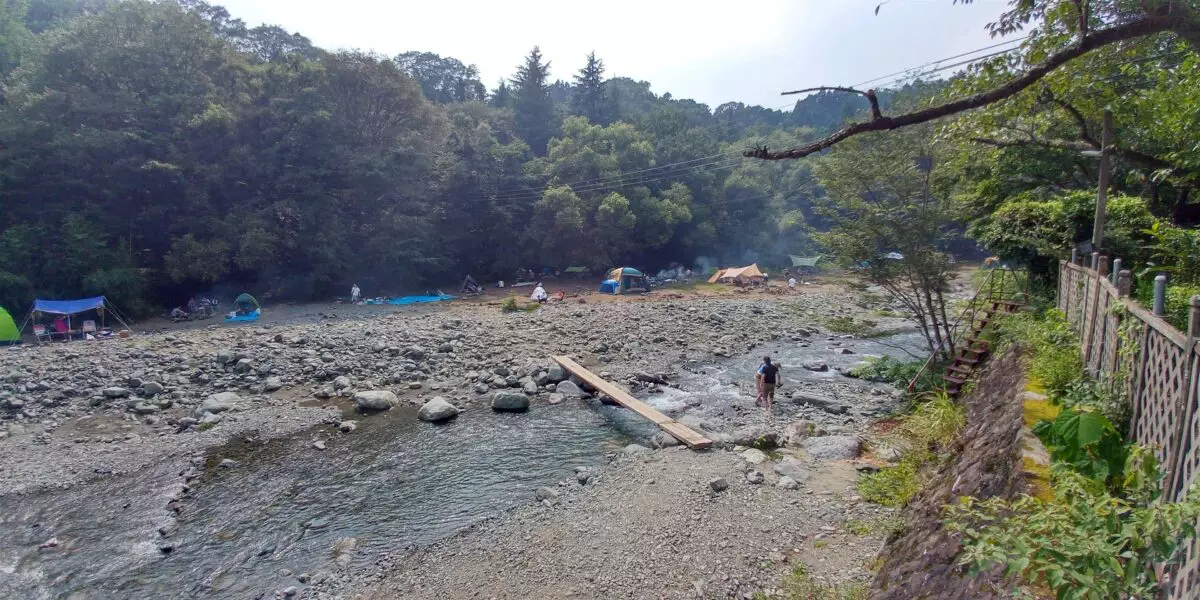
<box><xmin>1058</xmin><ymin>257</ymin><xmax>1200</xmax><ymax>600</ymax></box>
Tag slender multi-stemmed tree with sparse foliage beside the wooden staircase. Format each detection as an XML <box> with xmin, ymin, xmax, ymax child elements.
<box><xmin>815</xmin><ymin>126</ymin><xmax>954</xmax><ymax>359</ymax></box>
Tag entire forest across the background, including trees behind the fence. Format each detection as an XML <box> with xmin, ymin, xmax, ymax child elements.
<box><xmin>0</xmin><ymin>0</ymin><xmax>1200</xmax><ymax>313</ymax></box>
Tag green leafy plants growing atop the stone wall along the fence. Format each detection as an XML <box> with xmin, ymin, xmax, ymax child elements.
<box><xmin>946</xmin><ymin>311</ymin><xmax>1200</xmax><ymax>600</ymax></box>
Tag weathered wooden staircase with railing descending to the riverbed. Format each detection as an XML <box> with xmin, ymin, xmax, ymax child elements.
<box><xmin>908</xmin><ymin>268</ymin><xmax>1028</xmax><ymax>398</ymax></box>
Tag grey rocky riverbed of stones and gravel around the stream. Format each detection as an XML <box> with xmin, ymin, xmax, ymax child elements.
<box><xmin>0</xmin><ymin>292</ymin><xmax>926</xmax><ymax>598</ymax></box>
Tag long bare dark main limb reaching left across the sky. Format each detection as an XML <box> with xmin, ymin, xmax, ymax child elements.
<box><xmin>742</xmin><ymin>11</ymin><xmax>1180</xmax><ymax>161</ymax></box>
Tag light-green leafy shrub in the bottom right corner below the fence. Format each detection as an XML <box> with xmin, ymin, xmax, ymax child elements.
<box><xmin>946</xmin><ymin>449</ymin><xmax>1200</xmax><ymax>600</ymax></box>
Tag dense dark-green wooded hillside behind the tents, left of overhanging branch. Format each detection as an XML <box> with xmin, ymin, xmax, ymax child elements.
<box><xmin>0</xmin><ymin>0</ymin><xmax>897</xmax><ymax>310</ymax></box>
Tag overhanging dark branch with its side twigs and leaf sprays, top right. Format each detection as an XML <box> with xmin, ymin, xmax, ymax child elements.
<box><xmin>745</xmin><ymin>0</ymin><xmax>1200</xmax><ymax>160</ymax></box>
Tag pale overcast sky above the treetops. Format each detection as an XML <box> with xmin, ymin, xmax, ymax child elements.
<box><xmin>215</xmin><ymin>0</ymin><xmax>1006</xmax><ymax>108</ymax></box>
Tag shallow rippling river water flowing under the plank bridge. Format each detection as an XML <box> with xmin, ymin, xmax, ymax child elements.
<box><xmin>0</xmin><ymin>331</ymin><xmax>920</xmax><ymax>600</ymax></box>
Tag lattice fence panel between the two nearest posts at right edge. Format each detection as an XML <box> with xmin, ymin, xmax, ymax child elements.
<box><xmin>1130</xmin><ymin>329</ymin><xmax>1189</xmax><ymax>464</ymax></box>
